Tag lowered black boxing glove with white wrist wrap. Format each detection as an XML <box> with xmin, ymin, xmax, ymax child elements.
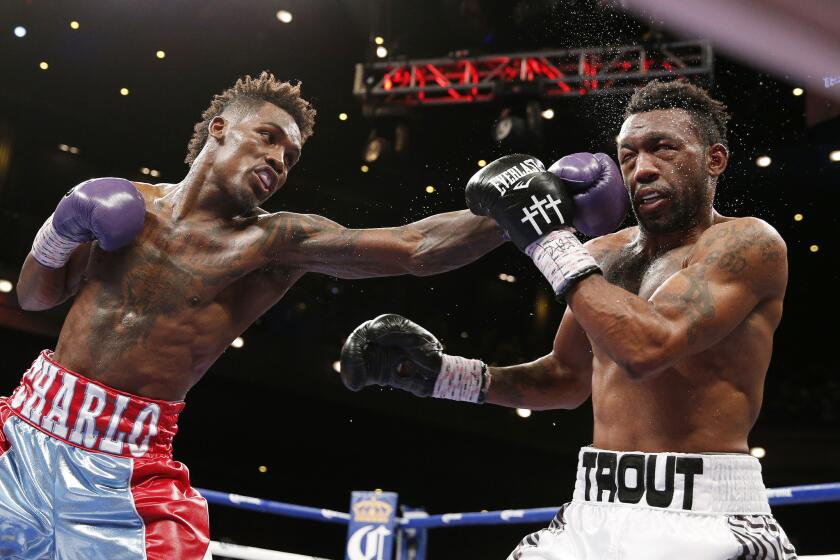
<box><xmin>341</xmin><ymin>314</ymin><xmax>490</xmax><ymax>403</ymax></box>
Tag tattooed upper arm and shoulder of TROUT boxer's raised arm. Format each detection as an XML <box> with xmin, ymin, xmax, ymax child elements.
<box><xmin>650</xmin><ymin>219</ymin><xmax>787</xmax><ymax>362</ymax></box>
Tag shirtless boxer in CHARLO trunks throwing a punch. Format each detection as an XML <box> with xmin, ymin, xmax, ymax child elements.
<box><xmin>0</xmin><ymin>73</ymin><xmax>502</xmax><ymax>560</ymax></box>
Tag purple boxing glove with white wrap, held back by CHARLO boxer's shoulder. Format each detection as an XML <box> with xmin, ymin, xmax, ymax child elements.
<box><xmin>32</xmin><ymin>177</ymin><xmax>145</xmax><ymax>268</ymax></box>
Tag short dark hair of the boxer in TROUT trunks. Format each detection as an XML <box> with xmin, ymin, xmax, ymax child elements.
<box><xmin>624</xmin><ymin>80</ymin><xmax>731</xmax><ymax>149</ymax></box>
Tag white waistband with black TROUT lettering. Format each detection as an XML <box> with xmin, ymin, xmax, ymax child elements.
<box><xmin>573</xmin><ymin>447</ymin><xmax>770</xmax><ymax>515</ymax></box>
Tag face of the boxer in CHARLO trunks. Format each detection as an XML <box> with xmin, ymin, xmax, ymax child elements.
<box><xmin>210</xmin><ymin>103</ymin><xmax>301</xmax><ymax>210</ymax></box>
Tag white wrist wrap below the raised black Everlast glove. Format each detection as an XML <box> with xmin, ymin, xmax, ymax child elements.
<box><xmin>525</xmin><ymin>229</ymin><xmax>601</xmax><ymax>296</ymax></box>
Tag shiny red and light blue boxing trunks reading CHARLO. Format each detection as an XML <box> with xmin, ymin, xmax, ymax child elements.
<box><xmin>0</xmin><ymin>350</ymin><xmax>210</xmax><ymax>560</ymax></box>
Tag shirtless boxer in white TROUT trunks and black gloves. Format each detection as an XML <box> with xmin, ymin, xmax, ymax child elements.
<box><xmin>341</xmin><ymin>82</ymin><xmax>796</xmax><ymax>560</ymax></box>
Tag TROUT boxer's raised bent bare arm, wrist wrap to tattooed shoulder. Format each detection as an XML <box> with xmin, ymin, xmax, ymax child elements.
<box><xmin>566</xmin><ymin>218</ymin><xmax>787</xmax><ymax>379</ymax></box>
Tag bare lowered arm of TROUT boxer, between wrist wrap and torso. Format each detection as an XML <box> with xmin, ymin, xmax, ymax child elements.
<box><xmin>485</xmin><ymin>308</ymin><xmax>592</xmax><ymax>410</ymax></box>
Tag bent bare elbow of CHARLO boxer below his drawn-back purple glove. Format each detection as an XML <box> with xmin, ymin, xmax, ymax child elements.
<box><xmin>15</xmin><ymin>243</ymin><xmax>91</xmax><ymax>311</ymax></box>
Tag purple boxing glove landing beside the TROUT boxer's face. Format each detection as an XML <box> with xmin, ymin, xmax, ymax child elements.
<box><xmin>548</xmin><ymin>152</ymin><xmax>630</xmax><ymax>237</ymax></box>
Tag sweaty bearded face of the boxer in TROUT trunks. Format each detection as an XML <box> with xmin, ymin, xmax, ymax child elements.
<box><xmin>616</xmin><ymin>109</ymin><xmax>720</xmax><ymax>233</ymax></box>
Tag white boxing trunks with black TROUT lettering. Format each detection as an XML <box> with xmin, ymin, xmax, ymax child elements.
<box><xmin>508</xmin><ymin>447</ymin><xmax>796</xmax><ymax>560</ymax></box>
